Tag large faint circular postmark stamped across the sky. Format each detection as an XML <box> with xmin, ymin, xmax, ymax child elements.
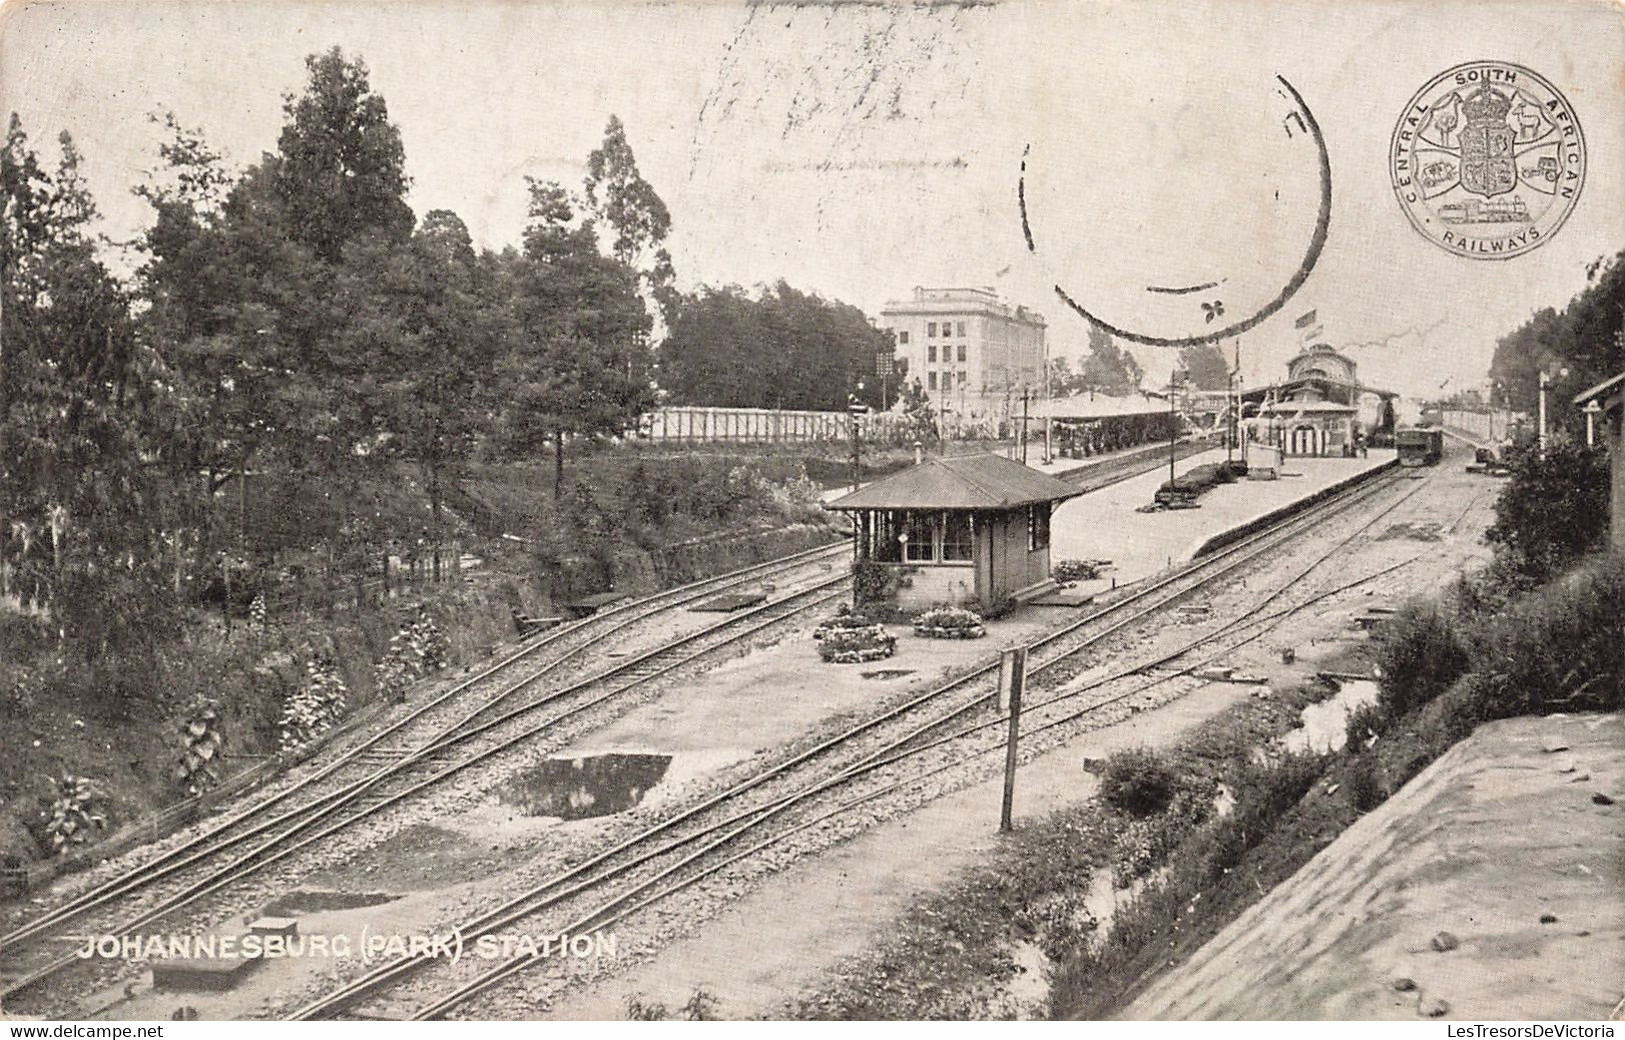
<box><xmin>1016</xmin><ymin>75</ymin><xmax>1333</xmax><ymax>346</ymax></box>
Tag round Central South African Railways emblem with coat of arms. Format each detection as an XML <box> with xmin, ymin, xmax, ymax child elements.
<box><xmin>1388</xmin><ymin>62</ymin><xmax>1586</xmax><ymax>260</ymax></box>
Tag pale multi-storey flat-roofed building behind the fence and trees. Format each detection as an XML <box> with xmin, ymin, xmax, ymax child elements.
<box><xmin>881</xmin><ymin>286</ymin><xmax>1045</xmax><ymax>419</ymax></box>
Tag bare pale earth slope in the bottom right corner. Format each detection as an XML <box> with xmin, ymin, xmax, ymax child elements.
<box><xmin>1125</xmin><ymin>715</ymin><xmax>1625</xmax><ymax>1021</ymax></box>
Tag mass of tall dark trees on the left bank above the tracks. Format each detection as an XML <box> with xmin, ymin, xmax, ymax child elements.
<box><xmin>0</xmin><ymin>49</ymin><xmax>676</xmax><ymax>647</ymax></box>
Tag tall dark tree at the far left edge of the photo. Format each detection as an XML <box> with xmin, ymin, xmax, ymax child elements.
<box><xmin>0</xmin><ymin>114</ymin><xmax>171</xmax><ymax>648</ymax></box>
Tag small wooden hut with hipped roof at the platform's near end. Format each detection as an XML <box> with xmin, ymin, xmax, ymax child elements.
<box><xmin>824</xmin><ymin>455</ymin><xmax>1082</xmax><ymax>613</ymax></box>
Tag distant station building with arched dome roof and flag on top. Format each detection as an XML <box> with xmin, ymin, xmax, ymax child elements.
<box><xmin>1240</xmin><ymin>343</ymin><xmax>1399</xmax><ymax>455</ymax></box>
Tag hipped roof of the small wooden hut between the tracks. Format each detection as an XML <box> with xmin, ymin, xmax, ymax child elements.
<box><xmin>824</xmin><ymin>455</ymin><xmax>1082</xmax><ymax>512</ymax></box>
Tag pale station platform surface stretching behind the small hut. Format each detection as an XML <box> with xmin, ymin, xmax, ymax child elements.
<box><xmin>1047</xmin><ymin>449</ymin><xmax>1396</xmax><ymax>605</ymax></box>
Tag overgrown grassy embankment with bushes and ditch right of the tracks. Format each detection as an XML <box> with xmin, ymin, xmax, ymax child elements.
<box><xmin>787</xmin><ymin>556</ymin><xmax>1625</xmax><ymax>1019</ymax></box>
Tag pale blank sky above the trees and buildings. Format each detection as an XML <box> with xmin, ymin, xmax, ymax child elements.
<box><xmin>0</xmin><ymin>0</ymin><xmax>1625</xmax><ymax>395</ymax></box>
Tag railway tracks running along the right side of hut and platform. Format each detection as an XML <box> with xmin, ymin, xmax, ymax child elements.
<box><xmin>291</xmin><ymin>461</ymin><xmax>1419</xmax><ymax>1019</ymax></box>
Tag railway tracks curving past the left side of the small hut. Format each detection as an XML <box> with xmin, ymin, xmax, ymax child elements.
<box><xmin>0</xmin><ymin>543</ymin><xmax>848</xmax><ymax>999</ymax></box>
